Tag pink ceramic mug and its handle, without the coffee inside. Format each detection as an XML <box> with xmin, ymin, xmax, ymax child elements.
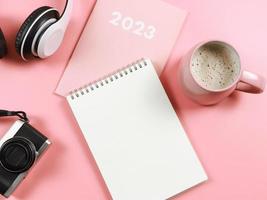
<box><xmin>178</xmin><ymin>41</ymin><xmax>265</xmax><ymax>105</ymax></box>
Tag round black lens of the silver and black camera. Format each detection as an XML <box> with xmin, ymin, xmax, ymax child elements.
<box><xmin>0</xmin><ymin>137</ymin><xmax>36</xmax><ymax>173</ymax></box>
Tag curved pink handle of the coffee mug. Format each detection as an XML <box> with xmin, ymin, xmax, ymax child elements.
<box><xmin>236</xmin><ymin>70</ymin><xmax>265</xmax><ymax>94</ymax></box>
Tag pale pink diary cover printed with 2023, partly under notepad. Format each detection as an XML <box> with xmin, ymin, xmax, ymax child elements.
<box><xmin>56</xmin><ymin>0</ymin><xmax>186</xmax><ymax>96</ymax></box>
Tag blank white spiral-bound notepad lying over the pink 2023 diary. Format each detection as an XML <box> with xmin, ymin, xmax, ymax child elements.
<box><xmin>67</xmin><ymin>59</ymin><xmax>207</xmax><ymax>200</ymax></box>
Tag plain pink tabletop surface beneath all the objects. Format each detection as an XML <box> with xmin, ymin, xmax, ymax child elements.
<box><xmin>0</xmin><ymin>0</ymin><xmax>267</xmax><ymax>200</ymax></box>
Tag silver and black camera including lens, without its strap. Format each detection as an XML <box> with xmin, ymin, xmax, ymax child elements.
<box><xmin>0</xmin><ymin>120</ymin><xmax>50</xmax><ymax>197</ymax></box>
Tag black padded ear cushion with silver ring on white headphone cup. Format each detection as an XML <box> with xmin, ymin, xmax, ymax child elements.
<box><xmin>15</xmin><ymin>6</ymin><xmax>59</xmax><ymax>60</ymax></box>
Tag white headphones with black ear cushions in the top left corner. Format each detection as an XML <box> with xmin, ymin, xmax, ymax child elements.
<box><xmin>0</xmin><ymin>0</ymin><xmax>73</xmax><ymax>60</ymax></box>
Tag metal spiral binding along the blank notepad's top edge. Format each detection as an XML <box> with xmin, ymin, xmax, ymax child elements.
<box><xmin>69</xmin><ymin>58</ymin><xmax>147</xmax><ymax>100</ymax></box>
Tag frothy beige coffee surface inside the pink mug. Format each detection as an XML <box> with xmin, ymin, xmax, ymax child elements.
<box><xmin>191</xmin><ymin>43</ymin><xmax>240</xmax><ymax>90</ymax></box>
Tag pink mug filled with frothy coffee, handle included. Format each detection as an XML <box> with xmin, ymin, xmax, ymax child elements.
<box><xmin>179</xmin><ymin>41</ymin><xmax>265</xmax><ymax>105</ymax></box>
